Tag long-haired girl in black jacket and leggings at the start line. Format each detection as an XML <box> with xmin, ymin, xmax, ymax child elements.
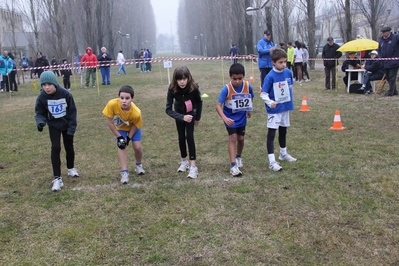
<box><xmin>165</xmin><ymin>66</ymin><xmax>202</xmax><ymax>178</ymax></box>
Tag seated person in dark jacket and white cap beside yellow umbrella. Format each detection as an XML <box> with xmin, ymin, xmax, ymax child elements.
<box><xmin>362</xmin><ymin>50</ymin><xmax>384</xmax><ymax>94</ymax></box>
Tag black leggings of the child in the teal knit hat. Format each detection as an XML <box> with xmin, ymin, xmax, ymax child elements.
<box><xmin>49</xmin><ymin>127</ymin><xmax>75</xmax><ymax>176</ymax></box>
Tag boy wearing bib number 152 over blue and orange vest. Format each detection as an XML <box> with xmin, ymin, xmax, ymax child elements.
<box><xmin>216</xmin><ymin>63</ymin><xmax>254</xmax><ymax>176</ymax></box>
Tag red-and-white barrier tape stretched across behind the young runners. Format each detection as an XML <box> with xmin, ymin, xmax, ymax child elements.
<box><xmin>9</xmin><ymin>55</ymin><xmax>399</xmax><ymax>71</ymax></box>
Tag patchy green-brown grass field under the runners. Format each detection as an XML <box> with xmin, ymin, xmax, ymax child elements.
<box><xmin>0</xmin><ymin>53</ymin><xmax>399</xmax><ymax>265</ymax></box>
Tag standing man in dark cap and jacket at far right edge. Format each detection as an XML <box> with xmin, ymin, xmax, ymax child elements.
<box><xmin>377</xmin><ymin>27</ymin><xmax>399</xmax><ymax>96</ymax></box>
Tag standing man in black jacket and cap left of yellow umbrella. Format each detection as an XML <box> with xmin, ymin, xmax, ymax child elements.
<box><xmin>321</xmin><ymin>37</ymin><xmax>342</xmax><ymax>90</ymax></box>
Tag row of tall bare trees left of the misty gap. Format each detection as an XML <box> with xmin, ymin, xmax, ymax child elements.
<box><xmin>3</xmin><ymin>0</ymin><xmax>156</xmax><ymax>59</ymax></box>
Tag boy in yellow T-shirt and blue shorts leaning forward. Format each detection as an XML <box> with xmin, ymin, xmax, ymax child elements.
<box><xmin>102</xmin><ymin>85</ymin><xmax>145</xmax><ymax>184</ymax></box>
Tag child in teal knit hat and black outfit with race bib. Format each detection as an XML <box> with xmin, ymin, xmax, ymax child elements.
<box><xmin>35</xmin><ymin>71</ymin><xmax>79</xmax><ymax>191</ymax></box>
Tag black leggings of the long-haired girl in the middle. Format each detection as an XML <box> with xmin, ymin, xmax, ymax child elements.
<box><xmin>176</xmin><ymin>117</ymin><xmax>196</xmax><ymax>160</ymax></box>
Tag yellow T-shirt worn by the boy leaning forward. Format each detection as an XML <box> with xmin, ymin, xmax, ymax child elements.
<box><xmin>103</xmin><ymin>98</ymin><xmax>143</xmax><ymax>131</ymax></box>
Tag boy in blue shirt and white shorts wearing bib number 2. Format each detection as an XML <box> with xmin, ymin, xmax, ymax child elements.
<box><xmin>260</xmin><ymin>49</ymin><xmax>296</xmax><ymax>171</ymax></box>
